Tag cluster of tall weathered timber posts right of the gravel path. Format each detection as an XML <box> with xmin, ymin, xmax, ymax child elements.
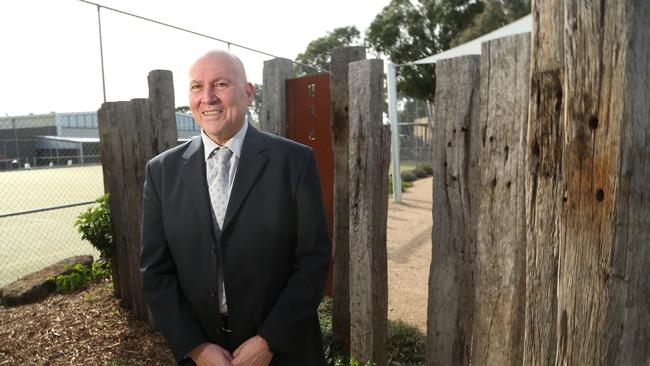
<box><xmin>427</xmin><ymin>0</ymin><xmax>650</xmax><ymax>365</ymax></box>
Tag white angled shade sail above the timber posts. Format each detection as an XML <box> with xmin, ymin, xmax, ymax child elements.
<box><xmin>413</xmin><ymin>14</ymin><xmax>533</xmax><ymax>64</ymax></box>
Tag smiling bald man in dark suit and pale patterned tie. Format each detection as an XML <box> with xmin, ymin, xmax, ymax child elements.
<box><xmin>140</xmin><ymin>51</ymin><xmax>330</xmax><ymax>366</ymax></box>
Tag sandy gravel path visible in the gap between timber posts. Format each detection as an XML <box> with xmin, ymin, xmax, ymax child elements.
<box><xmin>387</xmin><ymin>177</ymin><xmax>433</xmax><ymax>333</ymax></box>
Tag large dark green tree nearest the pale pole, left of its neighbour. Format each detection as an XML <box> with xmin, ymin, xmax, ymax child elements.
<box><xmin>366</xmin><ymin>0</ymin><xmax>483</xmax><ymax>101</ymax></box>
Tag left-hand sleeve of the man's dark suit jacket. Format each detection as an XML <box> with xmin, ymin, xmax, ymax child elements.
<box><xmin>140</xmin><ymin>161</ymin><xmax>207</xmax><ymax>361</ymax></box>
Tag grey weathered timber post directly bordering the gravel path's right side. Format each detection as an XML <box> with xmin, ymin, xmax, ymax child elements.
<box><xmin>426</xmin><ymin>56</ymin><xmax>481</xmax><ymax>366</ymax></box>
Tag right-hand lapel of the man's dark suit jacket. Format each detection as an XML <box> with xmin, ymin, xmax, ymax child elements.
<box><xmin>221</xmin><ymin>125</ymin><xmax>268</xmax><ymax>232</ymax></box>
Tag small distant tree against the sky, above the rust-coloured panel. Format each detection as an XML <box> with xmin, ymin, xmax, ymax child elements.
<box><xmin>296</xmin><ymin>25</ymin><xmax>361</xmax><ymax>70</ymax></box>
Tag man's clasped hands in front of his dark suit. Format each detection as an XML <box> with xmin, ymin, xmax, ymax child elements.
<box><xmin>189</xmin><ymin>336</ymin><xmax>273</xmax><ymax>366</ymax></box>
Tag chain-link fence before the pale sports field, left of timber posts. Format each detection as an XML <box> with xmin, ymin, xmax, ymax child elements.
<box><xmin>0</xmin><ymin>112</ymin><xmax>104</xmax><ymax>286</ymax></box>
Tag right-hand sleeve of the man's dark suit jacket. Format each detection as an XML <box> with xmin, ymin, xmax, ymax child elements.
<box><xmin>258</xmin><ymin>150</ymin><xmax>331</xmax><ymax>353</ymax></box>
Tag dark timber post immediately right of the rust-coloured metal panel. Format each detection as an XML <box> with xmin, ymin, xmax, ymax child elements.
<box><xmin>330</xmin><ymin>47</ymin><xmax>366</xmax><ymax>353</ymax></box>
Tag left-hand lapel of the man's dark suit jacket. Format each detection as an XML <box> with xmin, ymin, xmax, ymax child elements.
<box><xmin>181</xmin><ymin>137</ymin><xmax>212</xmax><ymax>233</ymax></box>
